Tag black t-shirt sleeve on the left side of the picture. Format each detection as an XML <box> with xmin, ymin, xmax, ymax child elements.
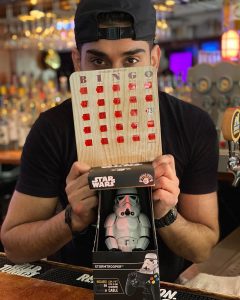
<box><xmin>16</xmin><ymin>113</ymin><xmax>62</xmax><ymax>197</ymax></box>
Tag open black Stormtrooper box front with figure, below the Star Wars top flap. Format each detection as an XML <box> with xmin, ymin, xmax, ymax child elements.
<box><xmin>93</xmin><ymin>187</ymin><xmax>160</xmax><ymax>300</ymax></box>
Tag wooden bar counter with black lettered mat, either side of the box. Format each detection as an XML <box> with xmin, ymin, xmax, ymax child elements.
<box><xmin>0</xmin><ymin>253</ymin><xmax>239</xmax><ymax>300</ymax></box>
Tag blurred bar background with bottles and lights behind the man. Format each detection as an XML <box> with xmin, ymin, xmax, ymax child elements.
<box><xmin>0</xmin><ymin>0</ymin><xmax>240</xmax><ymax>250</ymax></box>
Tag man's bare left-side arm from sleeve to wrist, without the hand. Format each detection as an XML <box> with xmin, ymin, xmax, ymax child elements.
<box><xmin>1</xmin><ymin>191</ymin><xmax>71</xmax><ymax>263</ymax></box>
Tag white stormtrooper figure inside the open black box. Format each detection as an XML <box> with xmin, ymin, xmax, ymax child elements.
<box><xmin>104</xmin><ymin>188</ymin><xmax>150</xmax><ymax>252</ymax></box>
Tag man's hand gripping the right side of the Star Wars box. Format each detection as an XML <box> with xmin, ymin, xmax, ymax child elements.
<box><xmin>153</xmin><ymin>155</ymin><xmax>180</xmax><ymax>219</ymax></box>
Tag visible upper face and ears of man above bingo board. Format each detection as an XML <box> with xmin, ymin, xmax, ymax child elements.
<box><xmin>72</xmin><ymin>39</ymin><xmax>160</xmax><ymax>71</ymax></box>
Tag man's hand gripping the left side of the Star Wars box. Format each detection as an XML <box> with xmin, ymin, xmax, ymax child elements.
<box><xmin>65</xmin><ymin>162</ymin><xmax>98</xmax><ymax>231</ymax></box>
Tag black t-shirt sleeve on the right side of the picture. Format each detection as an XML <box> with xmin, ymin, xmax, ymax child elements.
<box><xmin>180</xmin><ymin>112</ymin><xmax>219</xmax><ymax>194</ymax></box>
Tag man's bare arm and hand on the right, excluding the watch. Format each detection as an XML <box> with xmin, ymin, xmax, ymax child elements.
<box><xmin>153</xmin><ymin>155</ymin><xmax>219</xmax><ymax>262</ymax></box>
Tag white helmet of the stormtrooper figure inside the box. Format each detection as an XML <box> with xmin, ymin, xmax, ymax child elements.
<box><xmin>114</xmin><ymin>188</ymin><xmax>141</xmax><ymax>218</ymax></box>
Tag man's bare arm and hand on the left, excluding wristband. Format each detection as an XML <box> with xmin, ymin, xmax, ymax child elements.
<box><xmin>1</xmin><ymin>162</ymin><xmax>98</xmax><ymax>263</ymax></box>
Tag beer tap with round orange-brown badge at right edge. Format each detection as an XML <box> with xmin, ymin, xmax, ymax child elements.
<box><xmin>222</xmin><ymin>107</ymin><xmax>240</xmax><ymax>187</ymax></box>
